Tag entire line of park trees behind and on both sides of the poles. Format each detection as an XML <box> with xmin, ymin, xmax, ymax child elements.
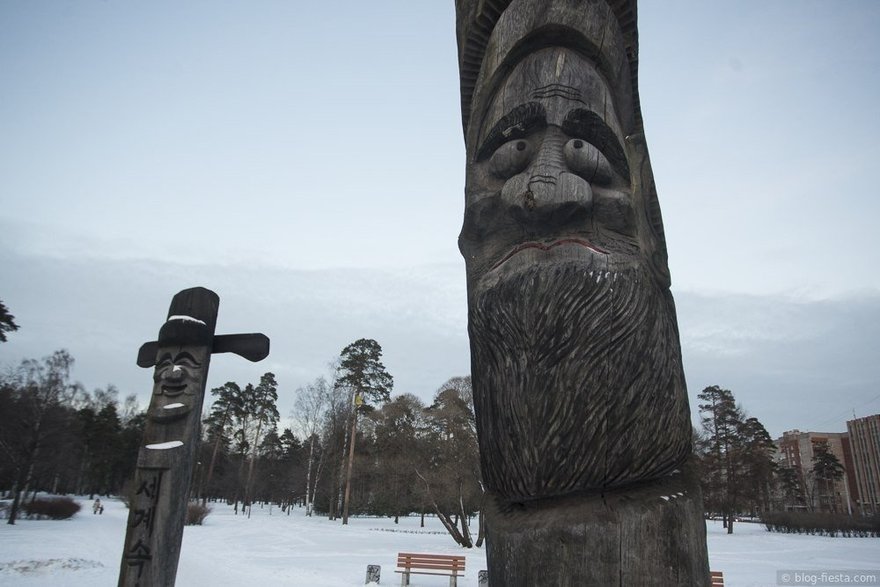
<box><xmin>0</xmin><ymin>330</ymin><xmax>844</xmax><ymax>547</ymax></box>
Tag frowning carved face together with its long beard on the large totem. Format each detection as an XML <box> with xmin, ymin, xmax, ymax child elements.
<box><xmin>459</xmin><ymin>46</ymin><xmax>690</xmax><ymax>501</ymax></box>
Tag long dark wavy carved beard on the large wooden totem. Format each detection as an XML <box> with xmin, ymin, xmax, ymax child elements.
<box><xmin>468</xmin><ymin>262</ymin><xmax>691</xmax><ymax>502</ymax></box>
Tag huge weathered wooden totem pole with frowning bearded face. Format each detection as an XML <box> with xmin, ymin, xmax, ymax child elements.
<box><xmin>456</xmin><ymin>0</ymin><xmax>709</xmax><ymax>587</ymax></box>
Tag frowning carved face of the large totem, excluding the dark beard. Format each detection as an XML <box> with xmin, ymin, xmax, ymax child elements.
<box><xmin>459</xmin><ymin>47</ymin><xmax>641</xmax><ymax>289</ymax></box>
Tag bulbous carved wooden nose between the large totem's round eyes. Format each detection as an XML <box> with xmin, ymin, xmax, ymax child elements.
<box><xmin>501</xmin><ymin>129</ymin><xmax>593</xmax><ymax>228</ymax></box>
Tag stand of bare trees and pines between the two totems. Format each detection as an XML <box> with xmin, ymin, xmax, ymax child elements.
<box><xmin>194</xmin><ymin>339</ymin><xmax>482</xmax><ymax>547</ymax></box>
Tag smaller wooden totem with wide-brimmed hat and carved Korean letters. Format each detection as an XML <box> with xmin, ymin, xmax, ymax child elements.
<box><xmin>119</xmin><ymin>287</ymin><xmax>269</xmax><ymax>587</ymax></box>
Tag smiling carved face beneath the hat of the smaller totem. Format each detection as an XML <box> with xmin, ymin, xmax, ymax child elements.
<box><xmin>150</xmin><ymin>346</ymin><xmax>207</xmax><ymax>422</ymax></box>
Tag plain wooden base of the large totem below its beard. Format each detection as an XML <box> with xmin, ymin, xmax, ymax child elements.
<box><xmin>478</xmin><ymin>466</ymin><xmax>709</xmax><ymax>587</ymax></box>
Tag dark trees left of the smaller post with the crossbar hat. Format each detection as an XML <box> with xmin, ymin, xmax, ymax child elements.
<box><xmin>0</xmin><ymin>350</ymin><xmax>145</xmax><ymax>524</ymax></box>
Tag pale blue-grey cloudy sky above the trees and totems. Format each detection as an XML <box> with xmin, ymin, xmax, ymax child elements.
<box><xmin>0</xmin><ymin>0</ymin><xmax>880</xmax><ymax>435</ymax></box>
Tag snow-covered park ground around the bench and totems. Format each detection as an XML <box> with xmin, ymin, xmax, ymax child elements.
<box><xmin>0</xmin><ymin>499</ymin><xmax>880</xmax><ymax>587</ymax></box>
